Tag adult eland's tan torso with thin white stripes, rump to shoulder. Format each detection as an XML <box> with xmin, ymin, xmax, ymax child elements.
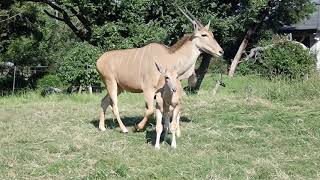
<box><xmin>97</xmin><ymin>43</ymin><xmax>170</xmax><ymax>92</ymax></box>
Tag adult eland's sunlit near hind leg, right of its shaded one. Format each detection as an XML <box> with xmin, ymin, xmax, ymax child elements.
<box><xmin>106</xmin><ymin>81</ymin><xmax>128</xmax><ymax>133</ymax></box>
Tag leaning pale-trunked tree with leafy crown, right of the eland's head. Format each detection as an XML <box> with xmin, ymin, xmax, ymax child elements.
<box><xmin>229</xmin><ymin>0</ymin><xmax>314</xmax><ymax>77</ymax></box>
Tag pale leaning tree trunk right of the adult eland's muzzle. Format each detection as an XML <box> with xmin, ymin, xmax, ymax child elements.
<box><xmin>229</xmin><ymin>24</ymin><xmax>257</xmax><ymax>77</ymax></box>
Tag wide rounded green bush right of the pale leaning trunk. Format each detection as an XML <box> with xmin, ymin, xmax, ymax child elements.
<box><xmin>238</xmin><ymin>38</ymin><xmax>315</xmax><ymax>79</ymax></box>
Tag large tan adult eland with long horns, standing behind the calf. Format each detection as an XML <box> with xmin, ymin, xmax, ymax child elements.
<box><xmin>97</xmin><ymin>8</ymin><xmax>223</xmax><ymax>133</ymax></box>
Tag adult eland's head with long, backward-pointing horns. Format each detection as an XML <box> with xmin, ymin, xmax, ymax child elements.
<box><xmin>178</xmin><ymin>7</ymin><xmax>223</xmax><ymax>57</ymax></box>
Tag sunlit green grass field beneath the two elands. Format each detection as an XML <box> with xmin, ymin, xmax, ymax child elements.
<box><xmin>0</xmin><ymin>76</ymin><xmax>320</xmax><ymax>179</ymax></box>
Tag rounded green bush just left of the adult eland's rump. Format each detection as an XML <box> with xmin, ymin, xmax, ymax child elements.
<box><xmin>57</xmin><ymin>43</ymin><xmax>101</xmax><ymax>86</ymax></box>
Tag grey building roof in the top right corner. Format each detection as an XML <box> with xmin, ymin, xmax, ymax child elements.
<box><xmin>282</xmin><ymin>0</ymin><xmax>320</xmax><ymax>31</ymax></box>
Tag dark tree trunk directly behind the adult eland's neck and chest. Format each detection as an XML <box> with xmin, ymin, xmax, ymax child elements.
<box><xmin>184</xmin><ymin>54</ymin><xmax>212</xmax><ymax>93</ymax></box>
